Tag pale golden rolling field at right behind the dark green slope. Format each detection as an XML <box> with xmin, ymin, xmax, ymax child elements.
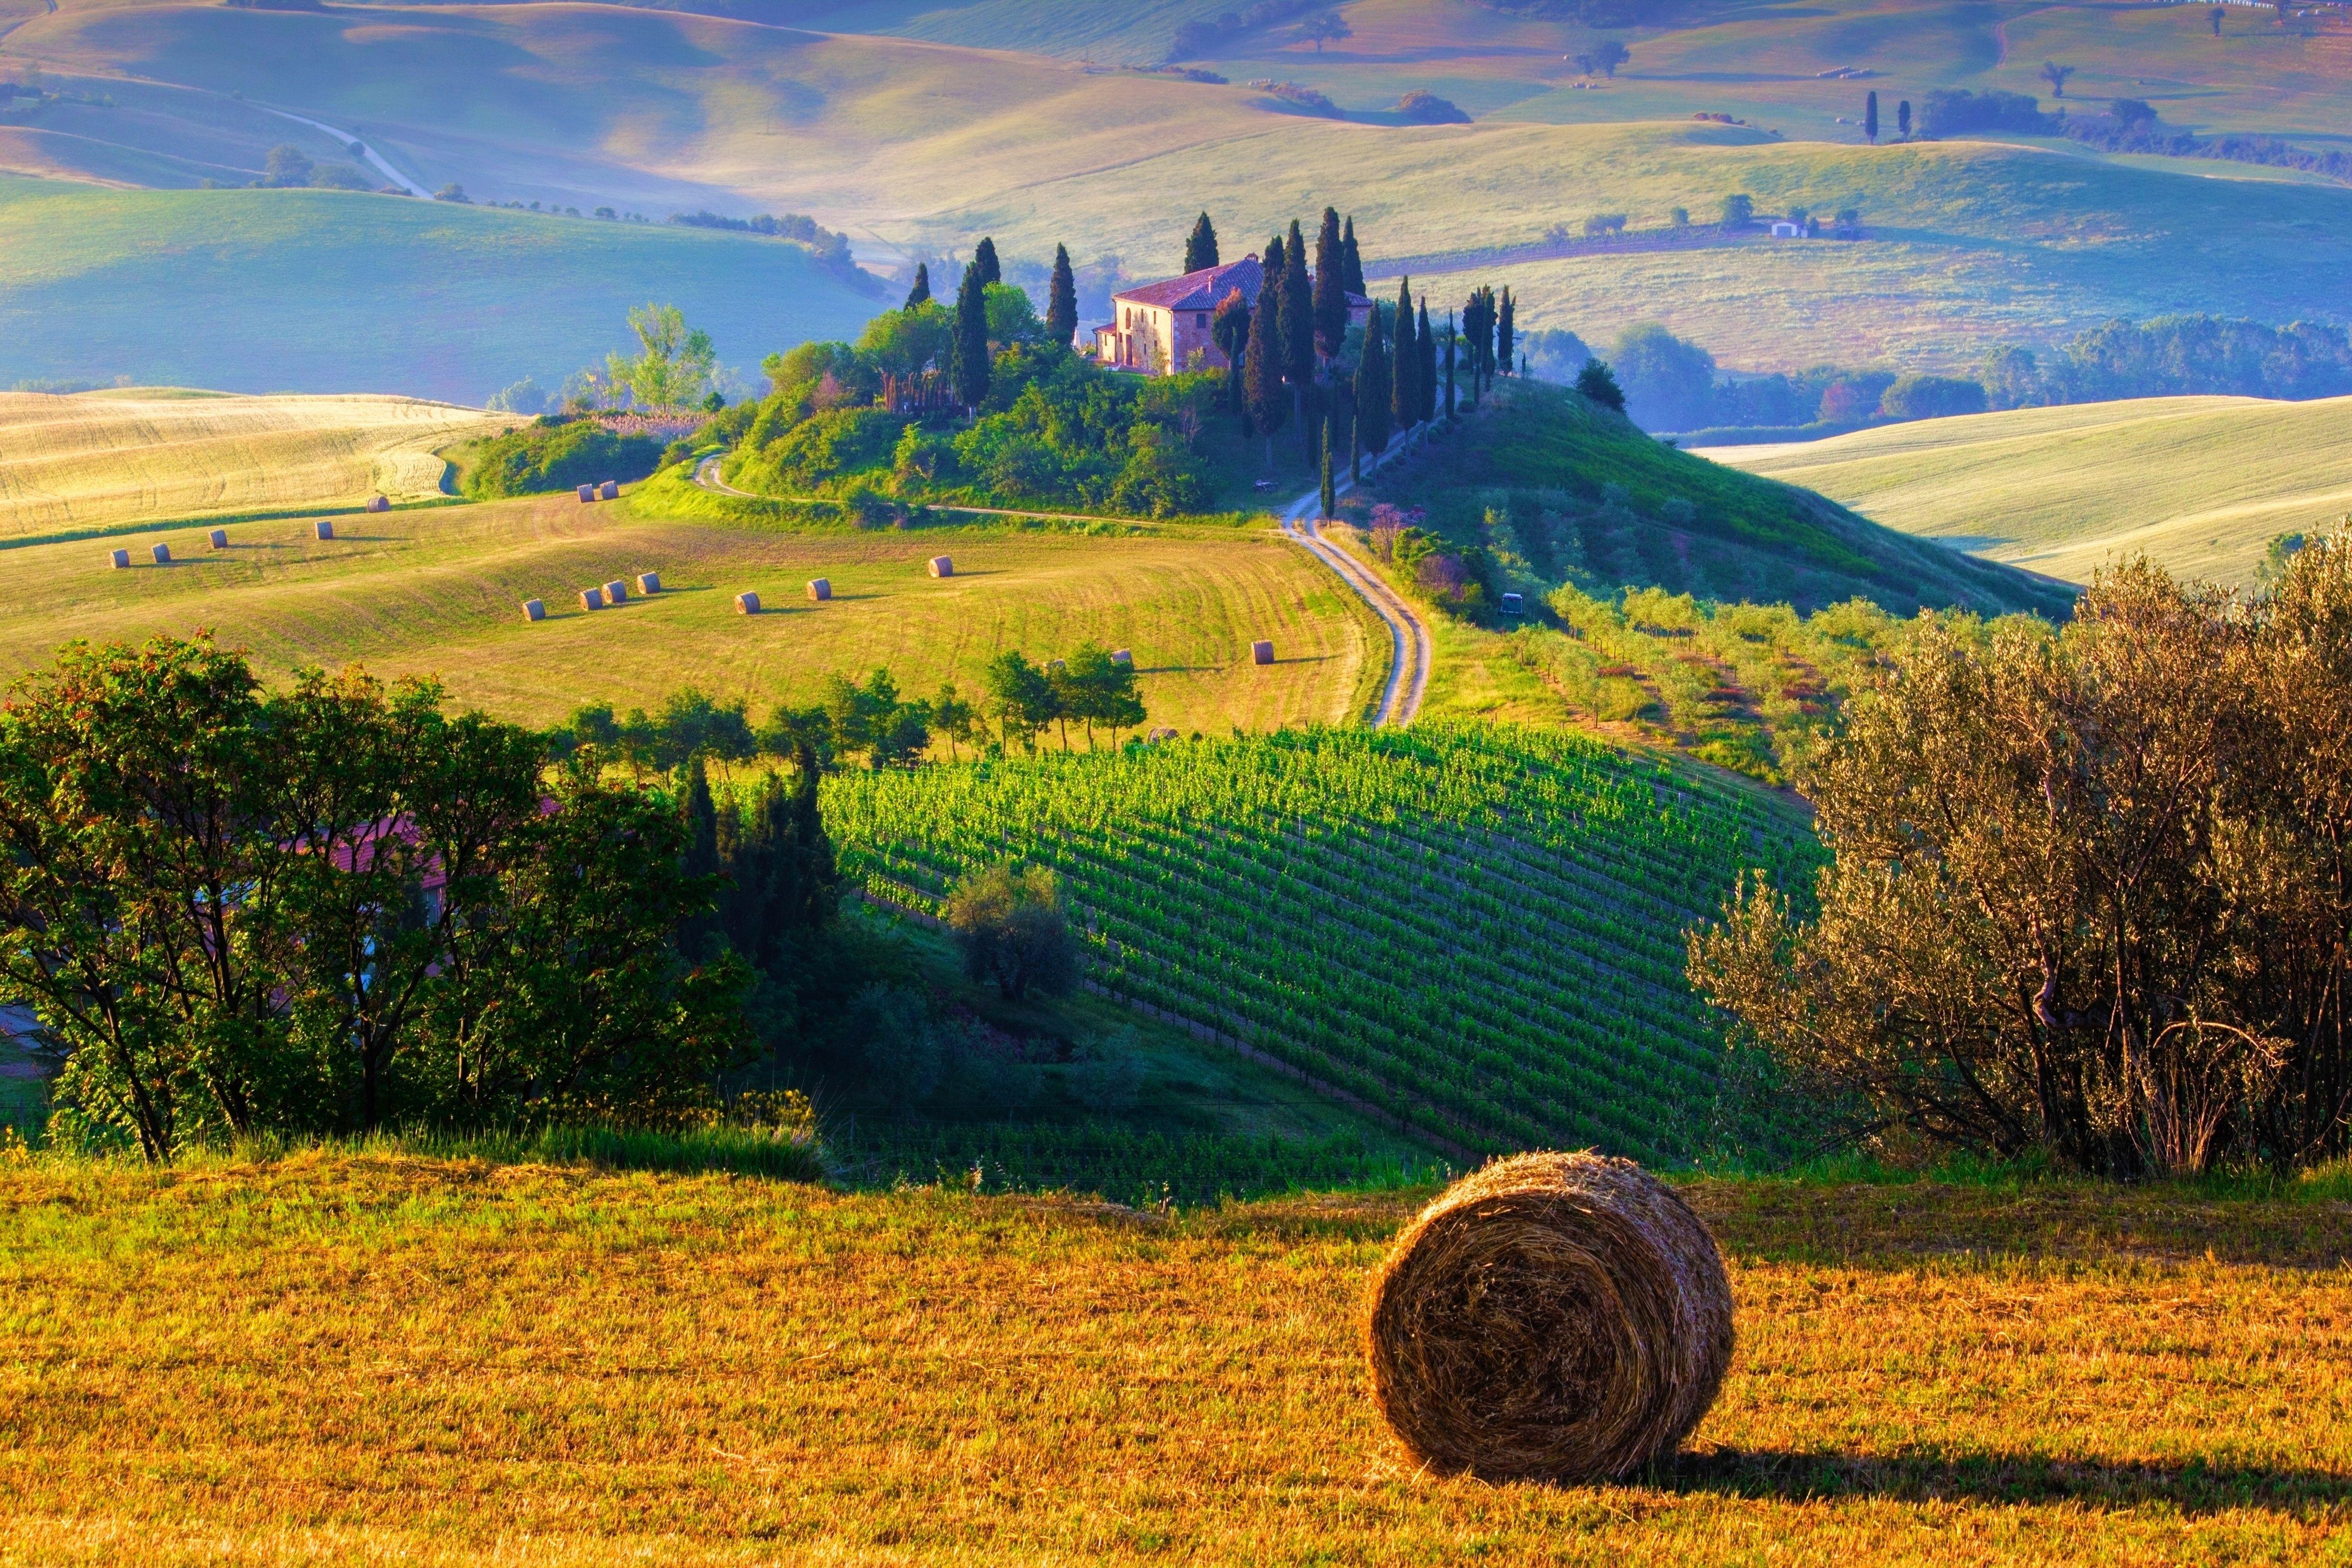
<box><xmin>1707</xmin><ymin>397</ymin><xmax>2352</xmax><ymax>585</ymax></box>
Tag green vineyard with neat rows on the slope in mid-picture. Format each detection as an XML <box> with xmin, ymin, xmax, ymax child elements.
<box><xmin>825</xmin><ymin>726</ymin><xmax>1818</xmax><ymax>1161</ymax></box>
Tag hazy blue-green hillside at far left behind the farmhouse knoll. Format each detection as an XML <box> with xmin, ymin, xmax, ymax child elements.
<box><xmin>0</xmin><ymin>177</ymin><xmax>877</xmax><ymax>404</ymax></box>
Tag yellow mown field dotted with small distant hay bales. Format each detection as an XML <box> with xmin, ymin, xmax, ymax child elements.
<box><xmin>0</xmin><ymin>484</ymin><xmax>1388</xmax><ymax>733</ymax></box>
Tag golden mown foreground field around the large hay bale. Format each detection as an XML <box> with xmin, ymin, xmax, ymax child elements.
<box><xmin>0</xmin><ymin>1157</ymin><xmax>2352</xmax><ymax>1566</ymax></box>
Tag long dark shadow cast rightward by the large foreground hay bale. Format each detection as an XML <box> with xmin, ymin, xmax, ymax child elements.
<box><xmin>1656</xmin><ymin>1448</ymin><xmax>2352</xmax><ymax>1514</ymax></box>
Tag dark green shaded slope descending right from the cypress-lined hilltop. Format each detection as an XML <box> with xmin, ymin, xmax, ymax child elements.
<box><xmin>1364</xmin><ymin>381</ymin><xmax>2072</xmax><ymax>616</ymax></box>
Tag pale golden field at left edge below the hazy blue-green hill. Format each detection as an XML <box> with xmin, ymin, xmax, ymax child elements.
<box><xmin>0</xmin><ymin>388</ymin><xmax>508</xmax><ymax>541</ymax></box>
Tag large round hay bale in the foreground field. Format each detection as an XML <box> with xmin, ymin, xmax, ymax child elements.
<box><xmin>1364</xmin><ymin>1152</ymin><xmax>1731</xmax><ymax>1483</ymax></box>
